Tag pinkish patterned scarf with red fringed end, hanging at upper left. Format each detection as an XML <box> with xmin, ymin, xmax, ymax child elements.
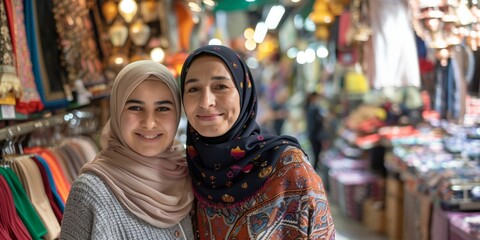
<box><xmin>9</xmin><ymin>0</ymin><xmax>43</xmax><ymax>114</ymax></box>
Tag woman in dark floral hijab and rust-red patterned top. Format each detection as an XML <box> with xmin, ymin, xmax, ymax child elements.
<box><xmin>180</xmin><ymin>46</ymin><xmax>334</xmax><ymax>239</ymax></box>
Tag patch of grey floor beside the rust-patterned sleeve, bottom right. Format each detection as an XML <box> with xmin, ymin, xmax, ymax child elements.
<box><xmin>330</xmin><ymin>204</ymin><xmax>388</xmax><ymax>240</ymax></box>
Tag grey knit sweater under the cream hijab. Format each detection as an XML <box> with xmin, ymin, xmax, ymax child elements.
<box><xmin>60</xmin><ymin>173</ymin><xmax>193</xmax><ymax>240</ymax></box>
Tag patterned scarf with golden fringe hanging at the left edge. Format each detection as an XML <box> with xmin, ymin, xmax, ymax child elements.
<box><xmin>0</xmin><ymin>1</ymin><xmax>22</xmax><ymax>98</ymax></box>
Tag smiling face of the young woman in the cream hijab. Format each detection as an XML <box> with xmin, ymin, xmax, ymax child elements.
<box><xmin>120</xmin><ymin>80</ymin><xmax>177</xmax><ymax>157</ymax></box>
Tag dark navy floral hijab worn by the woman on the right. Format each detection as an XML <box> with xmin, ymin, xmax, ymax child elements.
<box><xmin>180</xmin><ymin>45</ymin><xmax>300</xmax><ymax>206</ymax></box>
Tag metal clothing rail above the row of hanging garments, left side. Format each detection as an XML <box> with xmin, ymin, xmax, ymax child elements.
<box><xmin>0</xmin><ymin>110</ymin><xmax>94</xmax><ymax>141</ymax></box>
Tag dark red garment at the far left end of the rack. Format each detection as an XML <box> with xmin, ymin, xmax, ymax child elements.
<box><xmin>0</xmin><ymin>175</ymin><xmax>32</xmax><ymax>240</ymax></box>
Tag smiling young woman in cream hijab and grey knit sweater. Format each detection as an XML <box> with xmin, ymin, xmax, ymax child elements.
<box><xmin>60</xmin><ymin>60</ymin><xmax>193</xmax><ymax>240</ymax></box>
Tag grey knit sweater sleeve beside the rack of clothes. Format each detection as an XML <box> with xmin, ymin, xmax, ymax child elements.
<box><xmin>60</xmin><ymin>174</ymin><xmax>107</xmax><ymax>240</ymax></box>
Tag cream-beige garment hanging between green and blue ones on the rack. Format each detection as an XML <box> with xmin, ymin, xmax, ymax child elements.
<box><xmin>12</xmin><ymin>156</ymin><xmax>60</xmax><ymax>240</ymax></box>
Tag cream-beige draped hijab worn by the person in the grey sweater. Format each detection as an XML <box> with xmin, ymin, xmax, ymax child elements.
<box><xmin>82</xmin><ymin>60</ymin><xmax>193</xmax><ymax>228</ymax></box>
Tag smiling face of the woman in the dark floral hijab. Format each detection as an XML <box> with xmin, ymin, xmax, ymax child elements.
<box><xmin>183</xmin><ymin>56</ymin><xmax>240</xmax><ymax>137</ymax></box>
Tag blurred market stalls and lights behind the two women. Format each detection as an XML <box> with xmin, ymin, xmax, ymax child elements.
<box><xmin>0</xmin><ymin>0</ymin><xmax>480</xmax><ymax>240</ymax></box>
